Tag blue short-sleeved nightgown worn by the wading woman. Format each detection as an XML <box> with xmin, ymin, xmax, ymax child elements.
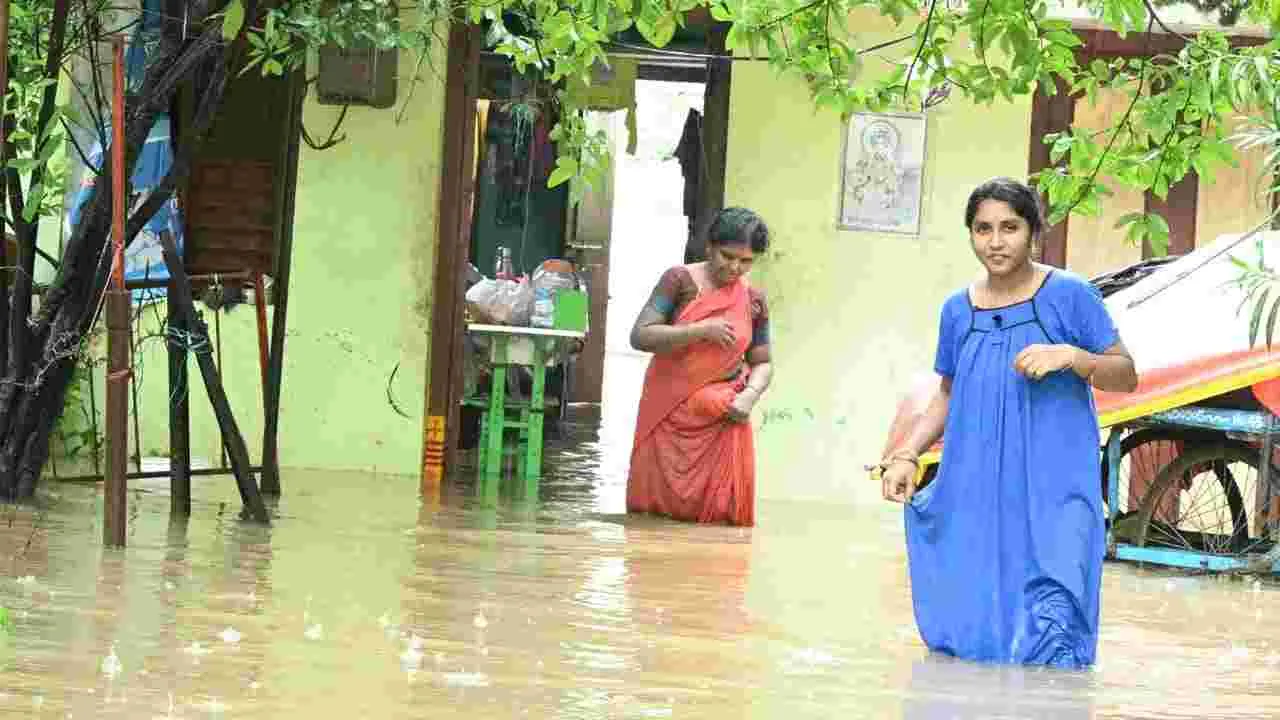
<box><xmin>906</xmin><ymin>270</ymin><xmax>1119</xmax><ymax>667</ymax></box>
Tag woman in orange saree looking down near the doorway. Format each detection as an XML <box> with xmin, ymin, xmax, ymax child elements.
<box><xmin>627</xmin><ymin>208</ymin><xmax>773</xmax><ymax>525</ymax></box>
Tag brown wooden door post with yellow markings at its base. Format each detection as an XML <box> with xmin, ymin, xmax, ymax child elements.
<box><xmin>421</xmin><ymin>24</ymin><xmax>481</xmax><ymax>492</ymax></box>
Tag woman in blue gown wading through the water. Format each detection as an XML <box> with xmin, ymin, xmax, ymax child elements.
<box><xmin>883</xmin><ymin>178</ymin><xmax>1138</xmax><ymax>667</ymax></box>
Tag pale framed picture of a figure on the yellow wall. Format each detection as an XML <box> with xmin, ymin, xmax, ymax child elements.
<box><xmin>837</xmin><ymin>113</ymin><xmax>927</xmax><ymax>234</ymax></box>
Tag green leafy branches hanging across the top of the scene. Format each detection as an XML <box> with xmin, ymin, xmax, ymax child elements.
<box><xmin>215</xmin><ymin>0</ymin><xmax>1280</xmax><ymax>254</ymax></box>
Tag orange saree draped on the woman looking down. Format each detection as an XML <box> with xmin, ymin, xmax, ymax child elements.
<box><xmin>627</xmin><ymin>271</ymin><xmax>755</xmax><ymax>525</ymax></box>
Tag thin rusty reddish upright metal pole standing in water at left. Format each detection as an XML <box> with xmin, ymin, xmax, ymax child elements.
<box><xmin>102</xmin><ymin>35</ymin><xmax>129</xmax><ymax>547</ymax></box>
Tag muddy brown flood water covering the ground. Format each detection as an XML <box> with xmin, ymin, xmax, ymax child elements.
<box><xmin>0</xmin><ymin>404</ymin><xmax>1280</xmax><ymax>720</ymax></box>
